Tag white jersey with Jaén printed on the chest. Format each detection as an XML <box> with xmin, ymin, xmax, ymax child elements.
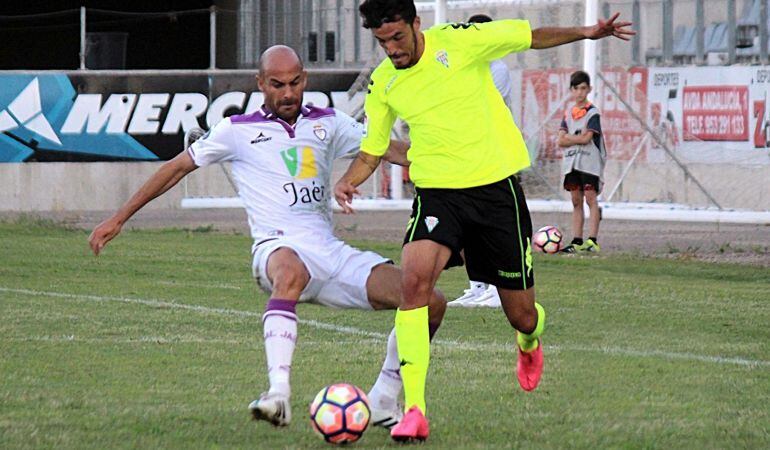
<box><xmin>188</xmin><ymin>106</ymin><xmax>364</xmax><ymax>243</ymax></box>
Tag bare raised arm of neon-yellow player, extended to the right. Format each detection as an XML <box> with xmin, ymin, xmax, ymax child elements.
<box><xmin>531</xmin><ymin>13</ymin><xmax>636</xmax><ymax>49</ymax></box>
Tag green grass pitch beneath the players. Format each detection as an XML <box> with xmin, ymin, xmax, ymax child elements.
<box><xmin>0</xmin><ymin>221</ymin><xmax>770</xmax><ymax>449</ymax></box>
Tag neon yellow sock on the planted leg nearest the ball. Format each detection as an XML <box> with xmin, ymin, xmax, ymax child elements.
<box><xmin>396</xmin><ymin>306</ymin><xmax>430</xmax><ymax>414</ymax></box>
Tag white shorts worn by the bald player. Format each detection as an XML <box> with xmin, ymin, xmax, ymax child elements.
<box><xmin>251</xmin><ymin>237</ymin><xmax>391</xmax><ymax>310</ymax></box>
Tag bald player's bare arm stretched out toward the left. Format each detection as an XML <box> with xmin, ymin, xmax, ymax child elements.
<box><xmin>88</xmin><ymin>152</ymin><xmax>197</xmax><ymax>256</ymax></box>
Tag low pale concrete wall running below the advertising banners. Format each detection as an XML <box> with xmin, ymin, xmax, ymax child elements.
<box><xmin>0</xmin><ymin>160</ymin><xmax>770</xmax><ymax>212</ymax></box>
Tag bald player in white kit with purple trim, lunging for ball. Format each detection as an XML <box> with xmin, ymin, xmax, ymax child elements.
<box><xmin>89</xmin><ymin>45</ymin><xmax>446</xmax><ymax>428</ymax></box>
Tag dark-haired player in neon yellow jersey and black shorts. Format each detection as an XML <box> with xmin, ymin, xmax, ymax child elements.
<box><xmin>334</xmin><ymin>0</ymin><xmax>634</xmax><ymax>442</ymax></box>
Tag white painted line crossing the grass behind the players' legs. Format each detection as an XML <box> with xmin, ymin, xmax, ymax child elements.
<box><xmin>0</xmin><ymin>287</ymin><xmax>770</xmax><ymax>367</ymax></box>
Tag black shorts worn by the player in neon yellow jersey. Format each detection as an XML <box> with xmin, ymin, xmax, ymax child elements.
<box><xmin>404</xmin><ymin>176</ymin><xmax>534</xmax><ymax>290</ymax></box>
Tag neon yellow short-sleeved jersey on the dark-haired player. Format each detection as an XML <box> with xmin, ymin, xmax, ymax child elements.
<box><xmin>361</xmin><ymin>20</ymin><xmax>532</xmax><ymax>188</ymax></box>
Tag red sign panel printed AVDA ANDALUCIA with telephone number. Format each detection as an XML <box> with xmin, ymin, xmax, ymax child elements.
<box><xmin>682</xmin><ymin>86</ymin><xmax>749</xmax><ymax>141</ymax></box>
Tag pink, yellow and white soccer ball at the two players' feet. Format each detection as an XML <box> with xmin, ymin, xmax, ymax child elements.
<box><xmin>310</xmin><ymin>383</ymin><xmax>371</xmax><ymax>444</ymax></box>
